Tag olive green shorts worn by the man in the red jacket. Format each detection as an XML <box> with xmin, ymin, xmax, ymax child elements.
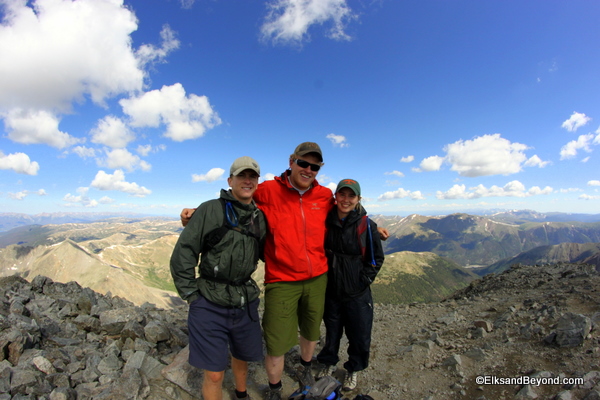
<box><xmin>262</xmin><ymin>273</ymin><xmax>327</xmax><ymax>357</ymax></box>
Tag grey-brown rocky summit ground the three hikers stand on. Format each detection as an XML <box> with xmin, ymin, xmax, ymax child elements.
<box><xmin>0</xmin><ymin>263</ymin><xmax>600</xmax><ymax>400</ymax></box>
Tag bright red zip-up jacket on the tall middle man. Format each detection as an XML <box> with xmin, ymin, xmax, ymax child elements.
<box><xmin>253</xmin><ymin>171</ymin><xmax>334</xmax><ymax>283</ymax></box>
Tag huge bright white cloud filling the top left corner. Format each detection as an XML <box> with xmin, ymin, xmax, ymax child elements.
<box><xmin>0</xmin><ymin>0</ymin><xmax>145</xmax><ymax>112</ymax></box>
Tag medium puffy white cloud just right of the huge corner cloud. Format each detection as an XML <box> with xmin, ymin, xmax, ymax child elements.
<box><xmin>119</xmin><ymin>83</ymin><xmax>221</xmax><ymax>142</ymax></box>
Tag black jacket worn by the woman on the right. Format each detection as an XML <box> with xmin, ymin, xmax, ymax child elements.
<box><xmin>325</xmin><ymin>206</ymin><xmax>384</xmax><ymax>297</ymax></box>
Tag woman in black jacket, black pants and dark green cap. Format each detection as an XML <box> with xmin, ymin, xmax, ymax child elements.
<box><xmin>317</xmin><ymin>179</ymin><xmax>384</xmax><ymax>390</ymax></box>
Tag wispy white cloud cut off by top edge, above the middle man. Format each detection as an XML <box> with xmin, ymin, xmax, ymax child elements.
<box><xmin>261</xmin><ymin>0</ymin><xmax>356</xmax><ymax>44</ymax></box>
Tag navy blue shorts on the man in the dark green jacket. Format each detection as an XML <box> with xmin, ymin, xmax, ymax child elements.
<box><xmin>188</xmin><ymin>296</ymin><xmax>263</xmax><ymax>372</ymax></box>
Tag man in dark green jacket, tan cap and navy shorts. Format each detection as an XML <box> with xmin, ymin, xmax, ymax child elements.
<box><xmin>171</xmin><ymin>156</ymin><xmax>266</xmax><ymax>400</ymax></box>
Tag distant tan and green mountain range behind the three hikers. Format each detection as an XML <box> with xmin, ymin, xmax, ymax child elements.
<box><xmin>0</xmin><ymin>210</ymin><xmax>600</xmax><ymax>308</ymax></box>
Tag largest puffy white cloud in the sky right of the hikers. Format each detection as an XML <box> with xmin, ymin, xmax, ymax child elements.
<box><xmin>444</xmin><ymin>133</ymin><xmax>528</xmax><ymax>177</ymax></box>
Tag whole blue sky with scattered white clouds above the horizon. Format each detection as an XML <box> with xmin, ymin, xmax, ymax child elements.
<box><xmin>0</xmin><ymin>0</ymin><xmax>600</xmax><ymax>216</ymax></box>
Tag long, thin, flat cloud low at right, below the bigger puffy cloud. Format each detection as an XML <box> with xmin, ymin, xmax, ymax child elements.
<box><xmin>436</xmin><ymin>181</ymin><xmax>553</xmax><ymax>200</ymax></box>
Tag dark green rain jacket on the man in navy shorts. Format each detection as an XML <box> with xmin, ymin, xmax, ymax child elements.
<box><xmin>171</xmin><ymin>190</ymin><xmax>266</xmax><ymax>307</ymax></box>
